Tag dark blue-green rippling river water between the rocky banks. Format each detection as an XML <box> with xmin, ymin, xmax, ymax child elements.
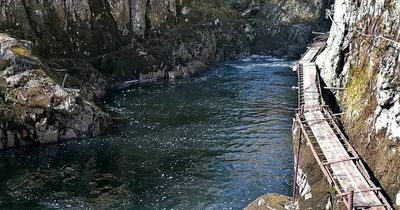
<box><xmin>0</xmin><ymin>56</ymin><xmax>296</xmax><ymax>210</ymax></box>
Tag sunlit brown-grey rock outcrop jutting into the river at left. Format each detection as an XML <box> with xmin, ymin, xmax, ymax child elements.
<box><xmin>0</xmin><ymin>34</ymin><xmax>109</xmax><ymax>149</ymax></box>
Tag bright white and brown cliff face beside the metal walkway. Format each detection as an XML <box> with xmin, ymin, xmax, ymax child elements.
<box><xmin>317</xmin><ymin>0</ymin><xmax>400</xmax><ymax>205</ymax></box>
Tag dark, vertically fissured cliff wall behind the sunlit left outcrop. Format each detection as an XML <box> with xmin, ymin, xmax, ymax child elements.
<box><xmin>0</xmin><ymin>0</ymin><xmax>177</xmax><ymax>57</ymax></box>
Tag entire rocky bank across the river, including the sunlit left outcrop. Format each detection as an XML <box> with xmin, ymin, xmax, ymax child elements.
<box><xmin>0</xmin><ymin>0</ymin><xmax>326</xmax><ymax>148</ymax></box>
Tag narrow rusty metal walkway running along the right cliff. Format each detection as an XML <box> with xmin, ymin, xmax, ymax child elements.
<box><xmin>294</xmin><ymin>41</ymin><xmax>393</xmax><ymax>209</ymax></box>
